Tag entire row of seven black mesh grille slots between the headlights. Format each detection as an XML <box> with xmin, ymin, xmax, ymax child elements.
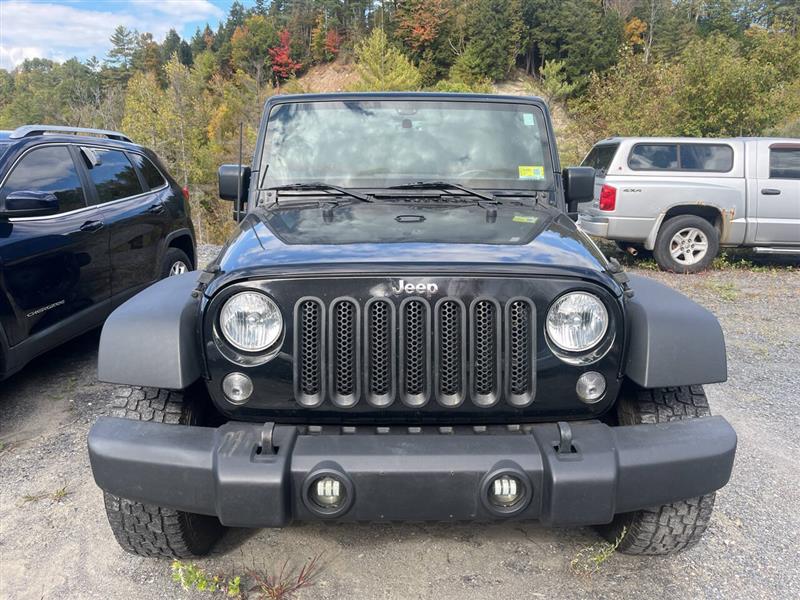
<box><xmin>295</xmin><ymin>297</ymin><xmax>536</xmax><ymax>408</ymax></box>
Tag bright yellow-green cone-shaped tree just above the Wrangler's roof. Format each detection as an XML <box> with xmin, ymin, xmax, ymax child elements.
<box><xmin>354</xmin><ymin>28</ymin><xmax>422</xmax><ymax>92</ymax></box>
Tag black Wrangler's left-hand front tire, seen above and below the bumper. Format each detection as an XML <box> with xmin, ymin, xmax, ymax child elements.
<box><xmin>103</xmin><ymin>387</ymin><xmax>224</xmax><ymax>558</ymax></box>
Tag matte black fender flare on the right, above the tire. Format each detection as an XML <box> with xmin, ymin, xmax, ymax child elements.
<box><xmin>624</xmin><ymin>275</ymin><xmax>728</xmax><ymax>388</ymax></box>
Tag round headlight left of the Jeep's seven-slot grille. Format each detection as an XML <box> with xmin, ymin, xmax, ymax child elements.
<box><xmin>219</xmin><ymin>292</ymin><xmax>283</xmax><ymax>352</ymax></box>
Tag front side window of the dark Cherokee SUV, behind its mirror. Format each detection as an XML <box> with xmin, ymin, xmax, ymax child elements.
<box><xmin>0</xmin><ymin>146</ymin><xmax>86</xmax><ymax>213</ymax></box>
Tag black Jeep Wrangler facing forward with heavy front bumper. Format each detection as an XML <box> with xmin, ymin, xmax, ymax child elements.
<box><xmin>89</xmin><ymin>94</ymin><xmax>736</xmax><ymax>557</ymax></box>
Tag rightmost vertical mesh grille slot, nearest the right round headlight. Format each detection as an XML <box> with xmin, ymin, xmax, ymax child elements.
<box><xmin>505</xmin><ymin>298</ymin><xmax>536</xmax><ymax>406</ymax></box>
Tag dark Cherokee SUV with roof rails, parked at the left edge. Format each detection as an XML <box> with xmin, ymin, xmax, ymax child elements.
<box><xmin>0</xmin><ymin>125</ymin><xmax>195</xmax><ymax>379</ymax></box>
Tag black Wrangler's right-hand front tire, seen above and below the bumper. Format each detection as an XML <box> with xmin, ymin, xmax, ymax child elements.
<box><xmin>598</xmin><ymin>386</ymin><xmax>715</xmax><ymax>555</ymax></box>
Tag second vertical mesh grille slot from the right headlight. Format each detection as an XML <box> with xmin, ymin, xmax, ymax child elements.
<box><xmin>470</xmin><ymin>298</ymin><xmax>500</xmax><ymax>406</ymax></box>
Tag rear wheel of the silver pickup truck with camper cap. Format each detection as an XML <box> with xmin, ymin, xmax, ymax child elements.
<box><xmin>653</xmin><ymin>215</ymin><xmax>719</xmax><ymax>273</ymax></box>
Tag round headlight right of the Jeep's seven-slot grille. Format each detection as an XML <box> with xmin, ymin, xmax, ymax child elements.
<box><xmin>547</xmin><ymin>292</ymin><xmax>608</xmax><ymax>352</ymax></box>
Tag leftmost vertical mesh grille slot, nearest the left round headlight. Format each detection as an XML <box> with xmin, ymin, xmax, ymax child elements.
<box><xmin>294</xmin><ymin>298</ymin><xmax>325</xmax><ymax>407</ymax></box>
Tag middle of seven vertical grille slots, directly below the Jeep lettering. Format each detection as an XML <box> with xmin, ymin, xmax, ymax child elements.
<box><xmin>400</xmin><ymin>298</ymin><xmax>431</xmax><ymax>407</ymax></box>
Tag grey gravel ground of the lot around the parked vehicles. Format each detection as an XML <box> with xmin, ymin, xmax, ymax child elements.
<box><xmin>0</xmin><ymin>247</ymin><xmax>800</xmax><ymax>600</ymax></box>
